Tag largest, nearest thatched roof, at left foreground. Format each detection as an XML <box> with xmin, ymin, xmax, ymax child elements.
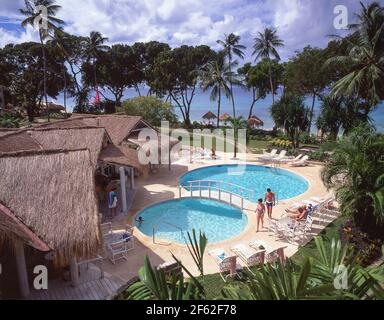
<box><xmin>0</xmin><ymin>149</ymin><xmax>101</xmax><ymax>265</ymax></box>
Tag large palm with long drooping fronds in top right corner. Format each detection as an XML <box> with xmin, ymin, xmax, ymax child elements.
<box><xmin>327</xmin><ymin>1</ymin><xmax>384</xmax><ymax>108</ymax></box>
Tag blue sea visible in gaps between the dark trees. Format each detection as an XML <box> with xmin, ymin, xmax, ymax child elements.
<box><xmin>54</xmin><ymin>87</ymin><xmax>384</xmax><ymax>133</ymax></box>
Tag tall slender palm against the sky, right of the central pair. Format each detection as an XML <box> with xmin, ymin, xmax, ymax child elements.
<box><xmin>252</xmin><ymin>28</ymin><xmax>284</xmax><ymax>104</ymax></box>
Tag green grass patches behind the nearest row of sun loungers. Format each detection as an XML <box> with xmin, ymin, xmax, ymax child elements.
<box><xmin>202</xmin><ymin>217</ymin><xmax>347</xmax><ymax>300</ymax></box>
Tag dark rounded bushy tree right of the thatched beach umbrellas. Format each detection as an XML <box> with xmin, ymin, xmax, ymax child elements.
<box><xmin>271</xmin><ymin>93</ymin><xmax>310</xmax><ymax>148</ymax></box>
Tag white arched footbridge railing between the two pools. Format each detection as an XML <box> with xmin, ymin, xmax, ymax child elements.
<box><xmin>179</xmin><ymin>180</ymin><xmax>255</xmax><ymax>210</ymax></box>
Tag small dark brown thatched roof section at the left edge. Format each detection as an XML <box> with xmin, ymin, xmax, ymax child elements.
<box><xmin>0</xmin><ymin>130</ymin><xmax>43</xmax><ymax>154</ymax></box>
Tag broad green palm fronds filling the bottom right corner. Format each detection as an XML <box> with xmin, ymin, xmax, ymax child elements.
<box><xmin>223</xmin><ymin>237</ymin><xmax>384</xmax><ymax>300</ymax></box>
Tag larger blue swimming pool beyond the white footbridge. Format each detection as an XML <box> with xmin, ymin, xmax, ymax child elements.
<box><xmin>179</xmin><ymin>165</ymin><xmax>309</xmax><ymax>202</ymax></box>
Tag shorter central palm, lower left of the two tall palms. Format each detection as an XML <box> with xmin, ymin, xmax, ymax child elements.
<box><xmin>201</xmin><ymin>53</ymin><xmax>232</xmax><ymax>127</ymax></box>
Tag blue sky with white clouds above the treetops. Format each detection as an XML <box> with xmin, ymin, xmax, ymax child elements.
<box><xmin>0</xmin><ymin>0</ymin><xmax>384</xmax><ymax>61</ymax></box>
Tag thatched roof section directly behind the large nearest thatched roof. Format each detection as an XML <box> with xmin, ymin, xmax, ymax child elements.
<box><xmin>28</xmin><ymin>127</ymin><xmax>110</xmax><ymax>168</ymax></box>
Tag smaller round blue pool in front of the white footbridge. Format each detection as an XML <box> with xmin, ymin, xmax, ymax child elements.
<box><xmin>135</xmin><ymin>198</ymin><xmax>248</xmax><ymax>244</ymax></box>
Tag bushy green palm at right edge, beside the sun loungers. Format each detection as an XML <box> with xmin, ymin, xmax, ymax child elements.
<box><xmin>322</xmin><ymin>124</ymin><xmax>384</xmax><ymax>238</ymax></box>
